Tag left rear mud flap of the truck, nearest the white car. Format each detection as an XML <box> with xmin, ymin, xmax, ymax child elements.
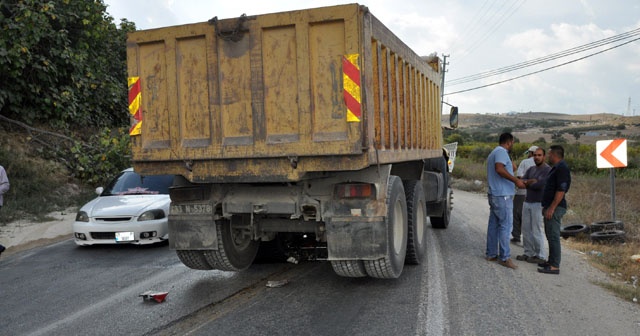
<box><xmin>169</xmin><ymin>217</ymin><xmax>218</xmax><ymax>250</ymax></box>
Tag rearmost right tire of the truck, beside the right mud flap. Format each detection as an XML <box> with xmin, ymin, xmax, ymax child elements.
<box><xmin>364</xmin><ymin>175</ymin><xmax>407</xmax><ymax>279</ymax></box>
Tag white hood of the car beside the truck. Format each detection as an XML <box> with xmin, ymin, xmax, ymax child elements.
<box><xmin>80</xmin><ymin>195</ymin><xmax>171</xmax><ymax>217</ymax></box>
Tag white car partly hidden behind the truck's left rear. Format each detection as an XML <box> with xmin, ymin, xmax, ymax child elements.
<box><xmin>73</xmin><ymin>168</ymin><xmax>174</xmax><ymax>246</ymax></box>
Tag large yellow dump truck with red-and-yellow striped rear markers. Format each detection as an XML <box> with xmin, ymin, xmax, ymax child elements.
<box><xmin>127</xmin><ymin>4</ymin><xmax>457</xmax><ymax>278</ymax></box>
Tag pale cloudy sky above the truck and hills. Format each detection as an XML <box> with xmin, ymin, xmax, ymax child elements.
<box><xmin>104</xmin><ymin>0</ymin><xmax>640</xmax><ymax>116</ymax></box>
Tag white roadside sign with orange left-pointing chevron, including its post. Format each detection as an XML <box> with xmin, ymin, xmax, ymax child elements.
<box><xmin>596</xmin><ymin>139</ymin><xmax>627</xmax><ymax>221</ymax></box>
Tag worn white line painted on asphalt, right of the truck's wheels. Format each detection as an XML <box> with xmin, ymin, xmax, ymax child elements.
<box><xmin>416</xmin><ymin>228</ymin><xmax>449</xmax><ymax>336</ymax></box>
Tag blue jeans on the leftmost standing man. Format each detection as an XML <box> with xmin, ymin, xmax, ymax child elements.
<box><xmin>486</xmin><ymin>195</ymin><xmax>513</xmax><ymax>261</ymax></box>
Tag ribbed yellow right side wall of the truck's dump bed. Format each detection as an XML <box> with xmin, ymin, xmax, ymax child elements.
<box><xmin>365</xmin><ymin>15</ymin><xmax>442</xmax><ymax>163</ymax></box>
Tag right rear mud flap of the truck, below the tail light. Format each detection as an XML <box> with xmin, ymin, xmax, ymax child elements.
<box><xmin>326</xmin><ymin>217</ymin><xmax>388</xmax><ymax>260</ymax></box>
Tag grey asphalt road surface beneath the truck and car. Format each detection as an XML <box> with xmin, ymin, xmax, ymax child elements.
<box><xmin>0</xmin><ymin>191</ymin><xmax>640</xmax><ymax>335</ymax></box>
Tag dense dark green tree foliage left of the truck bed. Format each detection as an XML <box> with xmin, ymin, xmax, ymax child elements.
<box><xmin>0</xmin><ymin>0</ymin><xmax>135</xmax><ymax>129</ymax></box>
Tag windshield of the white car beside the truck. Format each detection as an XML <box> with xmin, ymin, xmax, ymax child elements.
<box><xmin>100</xmin><ymin>171</ymin><xmax>173</xmax><ymax>196</ymax></box>
